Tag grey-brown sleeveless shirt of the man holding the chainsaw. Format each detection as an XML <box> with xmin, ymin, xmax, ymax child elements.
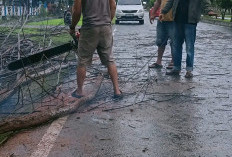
<box><xmin>82</xmin><ymin>0</ymin><xmax>111</xmax><ymax>28</ymax></box>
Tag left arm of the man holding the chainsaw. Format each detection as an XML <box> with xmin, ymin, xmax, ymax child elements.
<box><xmin>70</xmin><ymin>0</ymin><xmax>81</xmax><ymax>34</ymax></box>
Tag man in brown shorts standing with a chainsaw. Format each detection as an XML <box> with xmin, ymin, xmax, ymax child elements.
<box><xmin>70</xmin><ymin>0</ymin><xmax>123</xmax><ymax>98</ymax></box>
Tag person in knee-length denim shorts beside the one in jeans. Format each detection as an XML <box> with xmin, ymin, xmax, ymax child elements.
<box><xmin>149</xmin><ymin>0</ymin><xmax>174</xmax><ymax>69</ymax></box>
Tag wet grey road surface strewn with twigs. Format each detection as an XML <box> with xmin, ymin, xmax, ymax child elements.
<box><xmin>0</xmin><ymin>14</ymin><xmax>232</xmax><ymax>157</ymax></box>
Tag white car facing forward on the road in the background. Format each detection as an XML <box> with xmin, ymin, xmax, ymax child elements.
<box><xmin>115</xmin><ymin>0</ymin><xmax>144</xmax><ymax>24</ymax></box>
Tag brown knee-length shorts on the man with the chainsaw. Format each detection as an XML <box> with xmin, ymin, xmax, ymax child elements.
<box><xmin>77</xmin><ymin>25</ymin><xmax>114</xmax><ymax>67</ymax></box>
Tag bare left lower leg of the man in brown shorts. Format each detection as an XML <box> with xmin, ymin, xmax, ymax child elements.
<box><xmin>76</xmin><ymin>66</ymin><xmax>86</xmax><ymax>96</ymax></box>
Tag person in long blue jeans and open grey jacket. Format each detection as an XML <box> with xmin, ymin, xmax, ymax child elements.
<box><xmin>160</xmin><ymin>0</ymin><xmax>215</xmax><ymax>78</ymax></box>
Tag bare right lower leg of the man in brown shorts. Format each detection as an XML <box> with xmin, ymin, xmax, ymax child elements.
<box><xmin>107</xmin><ymin>63</ymin><xmax>121</xmax><ymax>95</ymax></box>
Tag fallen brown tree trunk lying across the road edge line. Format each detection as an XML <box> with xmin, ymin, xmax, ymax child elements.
<box><xmin>0</xmin><ymin>75</ymin><xmax>103</xmax><ymax>134</ymax></box>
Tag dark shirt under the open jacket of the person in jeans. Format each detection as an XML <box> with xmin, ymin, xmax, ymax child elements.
<box><xmin>174</xmin><ymin>0</ymin><xmax>189</xmax><ymax>24</ymax></box>
